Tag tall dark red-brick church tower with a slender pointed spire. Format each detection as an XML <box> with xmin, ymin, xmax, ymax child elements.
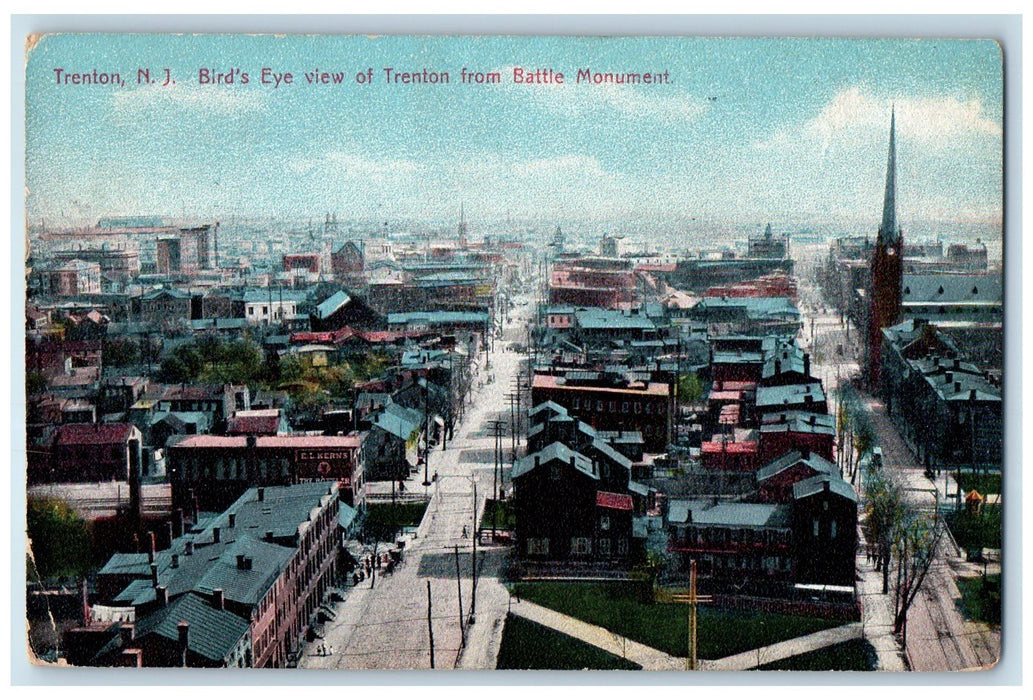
<box><xmin>865</xmin><ymin>113</ymin><xmax>904</xmax><ymax>390</ymax></box>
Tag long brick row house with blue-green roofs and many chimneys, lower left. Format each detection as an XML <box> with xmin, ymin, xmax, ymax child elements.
<box><xmin>76</xmin><ymin>481</ymin><xmax>341</xmax><ymax>668</ymax></box>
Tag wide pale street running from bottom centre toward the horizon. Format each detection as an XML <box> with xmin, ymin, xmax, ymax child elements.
<box><xmin>299</xmin><ymin>293</ymin><xmax>533</xmax><ymax>669</ymax></box>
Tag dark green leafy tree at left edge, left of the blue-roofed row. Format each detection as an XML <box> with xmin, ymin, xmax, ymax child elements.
<box><xmin>26</xmin><ymin>497</ymin><xmax>93</xmax><ymax>578</ymax></box>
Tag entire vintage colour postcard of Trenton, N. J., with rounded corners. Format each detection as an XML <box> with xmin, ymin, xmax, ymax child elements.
<box><xmin>25</xmin><ymin>33</ymin><xmax>1007</xmax><ymax>677</ymax></box>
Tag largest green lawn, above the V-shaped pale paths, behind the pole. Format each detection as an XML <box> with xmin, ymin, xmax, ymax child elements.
<box><xmin>514</xmin><ymin>582</ymin><xmax>842</xmax><ymax>659</ymax></box>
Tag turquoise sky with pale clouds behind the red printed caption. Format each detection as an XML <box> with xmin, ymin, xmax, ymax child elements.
<box><xmin>26</xmin><ymin>34</ymin><xmax>1003</xmax><ymax>225</ymax></box>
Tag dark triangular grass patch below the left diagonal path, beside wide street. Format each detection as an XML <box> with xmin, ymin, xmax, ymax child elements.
<box><xmin>495</xmin><ymin>615</ymin><xmax>641</xmax><ymax>671</ymax></box>
